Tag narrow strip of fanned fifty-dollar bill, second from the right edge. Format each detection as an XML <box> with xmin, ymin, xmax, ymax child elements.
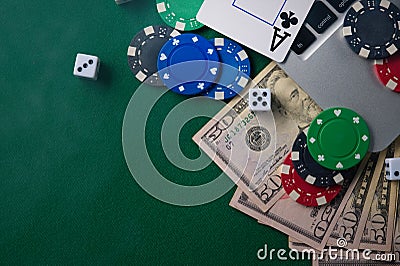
<box><xmin>327</xmin><ymin>153</ymin><xmax>385</xmax><ymax>248</ymax></box>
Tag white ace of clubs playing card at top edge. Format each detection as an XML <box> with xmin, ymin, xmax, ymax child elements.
<box><xmin>197</xmin><ymin>0</ymin><xmax>314</xmax><ymax>62</ymax></box>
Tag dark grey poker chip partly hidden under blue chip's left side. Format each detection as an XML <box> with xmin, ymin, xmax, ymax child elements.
<box><xmin>127</xmin><ymin>26</ymin><xmax>180</xmax><ymax>86</ymax></box>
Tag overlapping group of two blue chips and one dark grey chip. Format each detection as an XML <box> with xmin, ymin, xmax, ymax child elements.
<box><xmin>127</xmin><ymin>26</ymin><xmax>250</xmax><ymax>100</ymax></box>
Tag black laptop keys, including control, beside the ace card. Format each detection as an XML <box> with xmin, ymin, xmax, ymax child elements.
<box><xmin>291</xmin><ymin>0</ymin><xmax>356</xmax><ymax>55</ymax></box>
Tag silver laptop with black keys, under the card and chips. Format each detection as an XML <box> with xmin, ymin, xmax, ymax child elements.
<box><xmin>202</xmin><ymin>0</ymin><xmax>400</xmax><ymax>152</ymax></box>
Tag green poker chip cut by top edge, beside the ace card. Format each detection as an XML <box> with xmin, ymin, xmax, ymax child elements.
<box><xmin>157</xmin><ymin>0</ymin><xmax>204</xmax><ymax>31</ymax></box>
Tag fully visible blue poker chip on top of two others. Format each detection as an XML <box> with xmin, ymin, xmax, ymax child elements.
<box><xmin>157</xmin><ymin>33</ymin><xmax>220</xmax><ymax>95</ymax></box>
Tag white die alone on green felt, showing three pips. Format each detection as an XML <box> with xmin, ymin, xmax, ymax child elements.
<box><xmin>74</xmin><ymin>54</ymin><xmax>100</xmax><ymax>80</ymax></box>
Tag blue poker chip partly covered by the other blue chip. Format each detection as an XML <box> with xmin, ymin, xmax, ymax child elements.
<box><xmin>203</xmin><ymin>38</ymin><xmax>250</xmax><ymax>100</ymax></box>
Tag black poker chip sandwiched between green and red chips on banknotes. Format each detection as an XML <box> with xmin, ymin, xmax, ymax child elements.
<box><xmin>292</xmin><ymin>132</ymin><xmax>344</xmax><ymax>187</ymax></box>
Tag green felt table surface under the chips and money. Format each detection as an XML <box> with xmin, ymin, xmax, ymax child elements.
<box><xmin>0</xmin><ymin>0</ymin><xmax>310</xmax><ymax>265</ymax></box>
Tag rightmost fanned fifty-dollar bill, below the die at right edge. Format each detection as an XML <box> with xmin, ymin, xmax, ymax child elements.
<box><xmin>359</xmin><ymin>140</ymin><xmax>398</xmax><ymax>251</ymax></box>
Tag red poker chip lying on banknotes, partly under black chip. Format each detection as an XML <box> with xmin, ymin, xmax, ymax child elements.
<box><xmin>281</xmin><ymin>154</ymin><xmax>342</xmax><ymax>207</ymax></box>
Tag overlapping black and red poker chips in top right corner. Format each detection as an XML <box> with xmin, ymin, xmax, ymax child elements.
<box><xmin>343</xmin><ymin>0</ymin><xmax>400</xmax><ymax>92</ymax></box>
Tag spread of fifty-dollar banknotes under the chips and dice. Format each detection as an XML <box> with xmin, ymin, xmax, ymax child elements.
<box><xmin>193</xmin><ymin>63</ymin><xmax>400</xmax><ymax>265</ymax></box>
